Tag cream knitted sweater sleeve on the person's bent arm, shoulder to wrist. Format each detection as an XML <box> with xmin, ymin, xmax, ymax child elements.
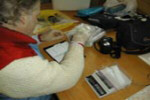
<box><xmin>0</xmin><ymin>45</ymin><xmax>84</xmax><ymax>98</ymax></box>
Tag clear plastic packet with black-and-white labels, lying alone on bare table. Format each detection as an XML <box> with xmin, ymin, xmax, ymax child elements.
<box><xmin>85</xmin><ymin>64</ymin><xmax>132</xmax><ymax>98</ymax></box>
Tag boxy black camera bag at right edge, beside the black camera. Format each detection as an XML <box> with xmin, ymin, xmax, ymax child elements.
<box><xmin>116</xmin><ymin>18</ymin><xmax>150</xmax><ymax>54</ymax></box>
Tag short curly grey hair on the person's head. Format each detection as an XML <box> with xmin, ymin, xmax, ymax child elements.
<box><xmin>0</xmin><ymin>0</ymin><xmax>39</xmax><ymax>24</ymax></box>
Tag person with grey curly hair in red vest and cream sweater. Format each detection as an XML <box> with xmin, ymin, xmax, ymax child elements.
<box><xmin>0</xmin><ymin>0</ymin><xmax>89</xmax><ymax>100</ymax></box>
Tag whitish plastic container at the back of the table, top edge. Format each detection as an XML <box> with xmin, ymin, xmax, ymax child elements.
<box><xmin>52</xmin><ymin>0</ymin><xmax>91</xmax><ymax>10</ymax></box>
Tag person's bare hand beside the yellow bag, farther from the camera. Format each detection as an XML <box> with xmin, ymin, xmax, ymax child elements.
<box><xmin>40</xmin><ymin>30</ymin><xmax>64</xmax><ymax>41</ymax></box>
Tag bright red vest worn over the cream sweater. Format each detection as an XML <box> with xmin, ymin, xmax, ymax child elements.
<box><xmin>0</xmin><ymin>27</ymin><xmax>37</xmax><ymax>69</ymax></box>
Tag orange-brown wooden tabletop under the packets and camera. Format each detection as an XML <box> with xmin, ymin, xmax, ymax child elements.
<box><xmin>40</xmin><ymin>3</ymin><xmax>150</xmax><ymax>100</ymax></box>
